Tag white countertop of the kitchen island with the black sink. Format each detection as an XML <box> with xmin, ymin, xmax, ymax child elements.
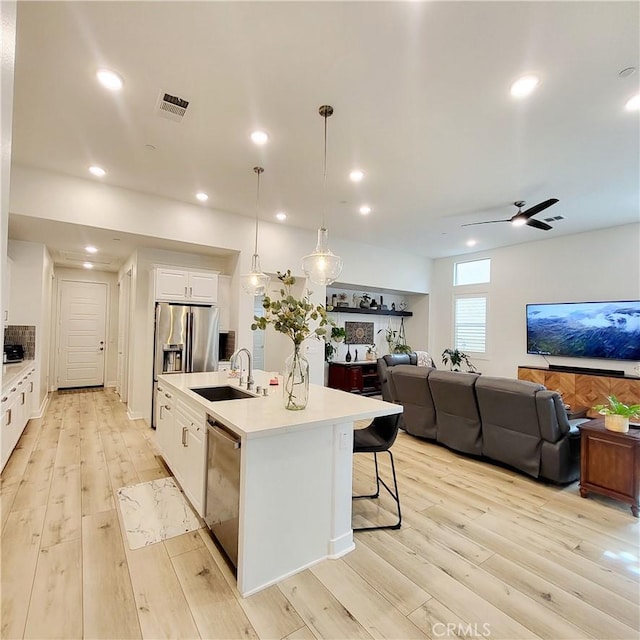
<box><xmin>158</xmin><ymin>371</ymin><xmax>402</xmax><ymax>438</ymax></box>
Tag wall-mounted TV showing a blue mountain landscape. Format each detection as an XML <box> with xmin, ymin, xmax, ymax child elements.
<box><xmin>527</xmin><ymin>300</ymin><xmax>640</xmax><ymax>360</ymax></box>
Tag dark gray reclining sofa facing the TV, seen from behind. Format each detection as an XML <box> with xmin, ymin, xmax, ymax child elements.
<box><xmin>386</xmin><ymin>364</ymin><xmax>584</xmax><ymax>483</ymax></box>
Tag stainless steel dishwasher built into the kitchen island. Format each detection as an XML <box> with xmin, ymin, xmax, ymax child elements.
<box><xmin>204</xmin><ymin>416</ymin><xmax>240</xmax><ymax>567</ymax></box>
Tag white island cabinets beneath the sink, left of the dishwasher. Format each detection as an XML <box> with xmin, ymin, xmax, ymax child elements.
<box><xmin>156</xmin><ymin>383</ymin><xmax>207</xmax><ymax>516</ymax></box>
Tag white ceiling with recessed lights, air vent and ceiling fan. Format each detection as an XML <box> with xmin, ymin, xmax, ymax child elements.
<box><xmin>10</xmin><ymin>1</ymin><xmax>640</xmax><ymax>268</ymax></box>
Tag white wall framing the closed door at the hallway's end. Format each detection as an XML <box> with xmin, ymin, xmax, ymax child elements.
<box><xmin>54</xmin><ymin>267</ymin><xmax>119</xmax><ymax>387</ymax></box>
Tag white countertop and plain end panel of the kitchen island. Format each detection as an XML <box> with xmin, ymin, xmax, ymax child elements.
<box><xmin>160</xmin><ymin>371</ymin><xmax>402</xmax><ymax>597</ymax></box>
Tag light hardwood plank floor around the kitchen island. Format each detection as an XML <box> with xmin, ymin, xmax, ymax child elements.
<box><xmin>1</xmin><ymin>390</ymin><xmax>639</xmax><ymax>639</ymax></box>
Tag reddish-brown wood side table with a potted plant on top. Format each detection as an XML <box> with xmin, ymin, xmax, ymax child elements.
<box><xmin>579</xmin><ymin>418</ymin><xmax>640</xmax><ymax>518</ymax></box>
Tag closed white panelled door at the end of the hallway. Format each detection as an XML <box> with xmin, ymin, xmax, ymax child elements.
<box><xmin>58</xmin><ymin>280</ymin><xmax>107</xmax><ymax>388</ymax></box>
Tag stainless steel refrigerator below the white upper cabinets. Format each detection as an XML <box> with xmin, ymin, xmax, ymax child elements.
<box><xmin>151</xmin><ymin>302</ymin><xmax>219</xmax><ymax>427</ymax></box>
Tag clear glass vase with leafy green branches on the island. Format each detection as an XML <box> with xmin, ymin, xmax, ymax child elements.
<box><xmin>251</xmin><ymin>269</ymin><xmax>333</xmax><ymax>411</ymax></box>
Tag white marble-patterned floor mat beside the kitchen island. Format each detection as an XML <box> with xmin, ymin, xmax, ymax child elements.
<box><xmin>116</xmin><ymin>478</ymin><xmax>201</xmax><ymax>549</ymax></box>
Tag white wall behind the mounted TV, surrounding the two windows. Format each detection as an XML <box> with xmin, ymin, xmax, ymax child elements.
<box><xmin>429</xmin><ymin>224</ymin><xmax>640</xmax><ymax>377</ymax></box>
